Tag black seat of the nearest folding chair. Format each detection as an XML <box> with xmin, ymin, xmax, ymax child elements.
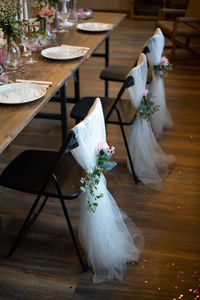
<box><xmin>0</xmin><ymin>150</ymin><xmax>82</xmax><ymax>199</ymax></box>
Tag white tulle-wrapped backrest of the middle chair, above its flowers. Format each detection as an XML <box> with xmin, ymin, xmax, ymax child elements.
<box><xmin>127</xmin><ymin>53</ymin><xmax>147</xmax><ymax>109</ymax></box>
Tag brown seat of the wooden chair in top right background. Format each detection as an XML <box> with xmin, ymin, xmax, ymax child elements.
<box><xmin>157</xmin><ymin>20</ymin><xmax>200</xmax><ymax>37</ymax></box>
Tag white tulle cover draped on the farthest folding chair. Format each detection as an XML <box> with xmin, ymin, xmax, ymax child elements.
<box><xmin>146</xmin><ymin>28</ymin><xmax>173</xmax><ymax>138</ymax></box>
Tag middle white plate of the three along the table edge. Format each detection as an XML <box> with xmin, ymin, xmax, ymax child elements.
<box><xmin>41</xmin><ymin>46</ymin><xmax>87</xmax><ymax>60</ymax></box>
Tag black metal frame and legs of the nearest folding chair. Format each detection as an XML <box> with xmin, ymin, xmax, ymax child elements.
<box><xmin>0</xmin><ymin>131</ymin><xmax>87</xmax><ymax>271</ymax></box>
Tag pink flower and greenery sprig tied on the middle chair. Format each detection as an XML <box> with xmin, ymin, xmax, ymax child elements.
<box><xmin>138</xmin><ymin>89</ymin><xmax>160</xmax><ymax>121</ymax></box>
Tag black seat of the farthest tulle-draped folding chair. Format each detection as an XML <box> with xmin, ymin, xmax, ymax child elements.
<box><xmin>100</xmin><ymin>65</ymin><xmax>131</xmax><ymax>82</ymax></box>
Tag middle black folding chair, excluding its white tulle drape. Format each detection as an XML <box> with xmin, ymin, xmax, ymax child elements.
<box><xmin>71</xmin><ymin>76</ymin><xmax>138</xmax><ymax>183</ymax></box>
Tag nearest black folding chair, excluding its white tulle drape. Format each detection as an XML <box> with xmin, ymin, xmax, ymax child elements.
<box><xmin>0</xmin><ymin>131</ymin><xmax>87</xmax><ymax>270</ymax></box>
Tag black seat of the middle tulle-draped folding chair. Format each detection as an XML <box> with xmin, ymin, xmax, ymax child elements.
<box><xmin>71</xmin><ymin>97</ymin><xmax>135</xmax><ymax>125</ymax></box>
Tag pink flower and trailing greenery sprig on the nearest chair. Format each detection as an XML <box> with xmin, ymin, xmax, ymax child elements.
<box><xmin>80</xmin><ymin>141</ymin><xmax>117</xmax><ymax>213</ymax></box>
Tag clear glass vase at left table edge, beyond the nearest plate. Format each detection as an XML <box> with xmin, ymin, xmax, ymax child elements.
<box><xmin>2</xmin><ymin>39</ymin><xmax>21</xmax><ymax>70</ymax></box>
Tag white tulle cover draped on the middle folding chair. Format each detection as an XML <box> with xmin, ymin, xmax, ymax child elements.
<box><xmin>127</xmin><ymin>53</ymin><xmax>175</xmax><ymax>190</ymax></box>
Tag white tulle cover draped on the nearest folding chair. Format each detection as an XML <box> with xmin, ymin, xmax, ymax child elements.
<box><xmin>72</xmin><ymin>98</ymin><xmax>143</xmax><ymax>283</ymax></box>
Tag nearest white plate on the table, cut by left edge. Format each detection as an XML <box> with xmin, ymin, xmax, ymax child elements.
<box><xmin>0</xmin><ymin>83</ymin><xmax>46</xmax><ymax>104</ymax></box>
